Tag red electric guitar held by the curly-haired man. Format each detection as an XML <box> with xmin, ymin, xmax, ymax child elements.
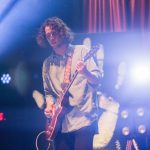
<box><xmin>46</xmin><ymin>46</ymin><xmax>99</xmax><ymax>141</ymax></box>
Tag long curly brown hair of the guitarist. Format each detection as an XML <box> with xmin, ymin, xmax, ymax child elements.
<box><xmin>36</xmin><ymin>17</ymin><xmax>74</xmax><ymax>47</ymax></box>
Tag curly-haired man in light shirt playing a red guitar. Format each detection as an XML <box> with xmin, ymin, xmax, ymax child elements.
<box><xmin>37</xmin><ymin>17</ymin><xmax>103</xmax><ymax>150</ymax></box>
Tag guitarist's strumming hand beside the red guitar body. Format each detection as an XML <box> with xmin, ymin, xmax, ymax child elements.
<box><xmin>44</xmin><ymin>100</ymin><xmax>56</xmax><ymax>118</ymax></box>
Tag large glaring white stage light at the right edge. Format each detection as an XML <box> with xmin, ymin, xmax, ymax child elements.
<box><xmin>130</xmin><ymin>63</ymin><xmax>150</xmax><ymax>84</ymax></box>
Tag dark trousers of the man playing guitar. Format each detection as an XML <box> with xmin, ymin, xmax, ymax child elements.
<box><xmin>54</xmin><ymin>122</ymin><xmax>97</xmax><ymax>150</ymax></box>
